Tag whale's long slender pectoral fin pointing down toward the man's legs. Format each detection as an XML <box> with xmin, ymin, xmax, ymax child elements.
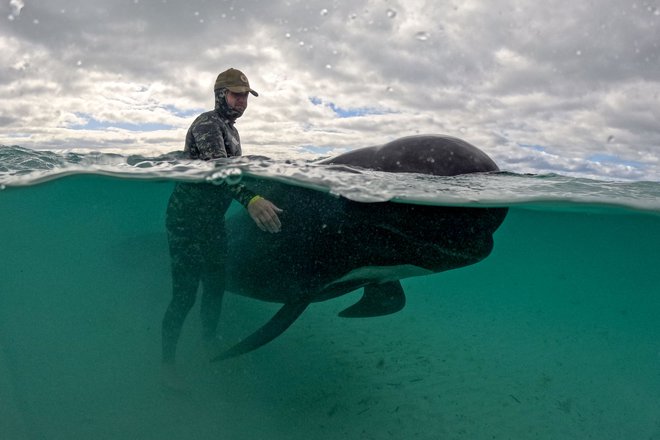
<box><xmin>211</xmin><ymin>302</ymin><xmax>309</xmax><ymax>362</ymax></box>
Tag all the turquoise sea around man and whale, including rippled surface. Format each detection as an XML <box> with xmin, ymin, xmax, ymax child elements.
<box><xmin>0</xmin><ymin>147</ymin><xmax>660</xmax><ymax>440</ymax></box>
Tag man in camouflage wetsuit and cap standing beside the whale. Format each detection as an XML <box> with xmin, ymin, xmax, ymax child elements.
<box><xmin>162</xmin><ymin>68</ymin><xmax>282</xmax><ymax>389</ymax></box>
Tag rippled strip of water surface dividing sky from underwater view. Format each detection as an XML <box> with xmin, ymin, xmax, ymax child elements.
<box><xmin>0</xmin><ymin>146</ymin><xmax>660</xmax><ymax>213</ymax></box>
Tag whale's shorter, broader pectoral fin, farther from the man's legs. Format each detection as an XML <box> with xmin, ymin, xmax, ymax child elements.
<box><xmin>339</xmin><ymin>281</ymin><xmax>406</xmax><ymax>318</ymax></box>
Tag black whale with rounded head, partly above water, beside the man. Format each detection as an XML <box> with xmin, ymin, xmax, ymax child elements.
<box><xmin>211</xmin><ymin>135</ymin><xmax>507</xmax><ymax>361</ymax></box>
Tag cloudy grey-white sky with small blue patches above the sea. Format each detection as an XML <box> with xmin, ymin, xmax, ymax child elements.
<box><xmin>0</xmin><ymin>0</ymin><xmax>660</xmax><ymax>181</ymax></box>
